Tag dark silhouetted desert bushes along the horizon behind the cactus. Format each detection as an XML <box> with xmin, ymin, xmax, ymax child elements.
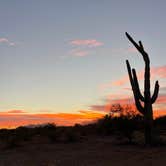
<box><xmin>0</xmin><ymin>104</ymin><xmax>166</xmax><ymax>148</ymax></box>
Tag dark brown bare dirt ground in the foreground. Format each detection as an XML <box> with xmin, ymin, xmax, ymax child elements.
<box><xmin>0</xmin><ymin>137</ymin><xmax>166</xmax><ymax>166</ymax></box>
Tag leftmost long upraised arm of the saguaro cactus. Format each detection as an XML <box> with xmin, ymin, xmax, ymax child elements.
<box><xmin>126</xmin><ymin>60</ymin><xmax>145</xmax><ymax>115</ymax></box>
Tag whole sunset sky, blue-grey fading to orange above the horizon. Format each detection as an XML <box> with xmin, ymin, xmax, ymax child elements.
<box><xmin>0</xmin><ymin>0</ymin><xmax>166</xmax><ymax>127</ymax></box>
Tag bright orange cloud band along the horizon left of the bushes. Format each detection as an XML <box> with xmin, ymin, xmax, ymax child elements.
<box><xmin>0</xmin><ymin>110</ymin><xmax>104</xmax><ymax>128</ymax></box>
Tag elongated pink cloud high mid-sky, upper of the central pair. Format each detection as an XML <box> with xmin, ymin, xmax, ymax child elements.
<box><xmin>70</xmin><ymin>39</ymin><xmax>104</xmax><ymax>47</ymax></box>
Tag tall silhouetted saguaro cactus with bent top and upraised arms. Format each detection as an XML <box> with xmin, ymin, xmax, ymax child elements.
<box><xmin>126</xmin><ymin>32</ymin><xmax>159</xmax><ymax>145</ymax></box>
